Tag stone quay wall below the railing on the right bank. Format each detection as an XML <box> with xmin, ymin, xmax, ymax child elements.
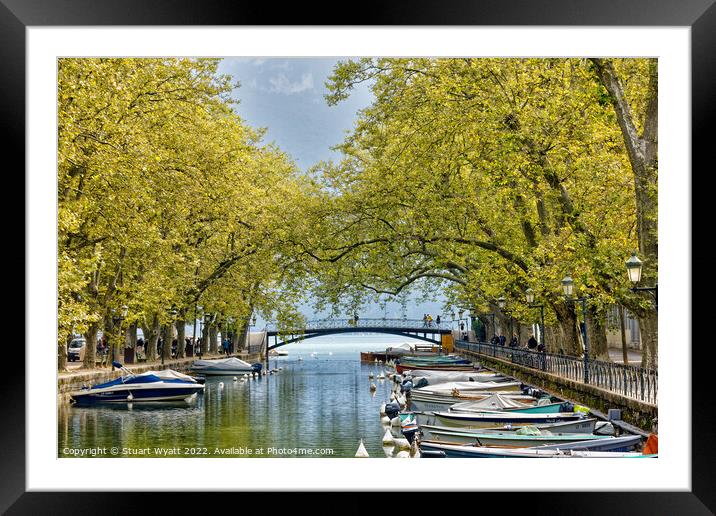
<box><xmin>458</xmin><ymin>349</ymin><xmax>658</xmax><ymax>433</ymax></box>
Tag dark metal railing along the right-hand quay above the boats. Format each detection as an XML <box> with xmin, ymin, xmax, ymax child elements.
<box><xmin>455</xmin><ymin>340</ymin><xmax>659</xmax><ymax>404</ymax></box>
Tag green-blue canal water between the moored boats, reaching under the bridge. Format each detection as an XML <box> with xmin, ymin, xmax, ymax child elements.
<box><xmin>58</xmin><ymin>334</ymin><xmax>415</xmax><ymax>458</ymax></box>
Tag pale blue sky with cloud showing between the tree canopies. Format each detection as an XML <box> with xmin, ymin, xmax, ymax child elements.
<box><xmin>219</xmin><ymin>57</ymin><xmax>442</xmax><ymax>327</ymax></box>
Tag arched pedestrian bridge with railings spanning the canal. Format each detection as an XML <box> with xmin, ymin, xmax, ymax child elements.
<box><xmin>266</xmin><ymin>318</ymin><xmax>454</xmax><ymax>350</ymax></box>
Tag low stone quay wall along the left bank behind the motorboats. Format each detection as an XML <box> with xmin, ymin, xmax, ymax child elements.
<box><xmin>57</xmin><ymin>353</ymin><xmax>264</xmax><ymax>403</ymax></box>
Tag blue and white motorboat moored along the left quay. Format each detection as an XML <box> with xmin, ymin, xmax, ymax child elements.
<box><xmin>70</xmin><ymin>362</ymin><xmax>204</xmax><ymax>405</ymax></box>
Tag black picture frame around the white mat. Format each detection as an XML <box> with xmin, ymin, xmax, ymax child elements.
<box><xmin>5</xmin><ymin>0</ymin><xmax>716</xmax><ymax>515</ymax></box>
